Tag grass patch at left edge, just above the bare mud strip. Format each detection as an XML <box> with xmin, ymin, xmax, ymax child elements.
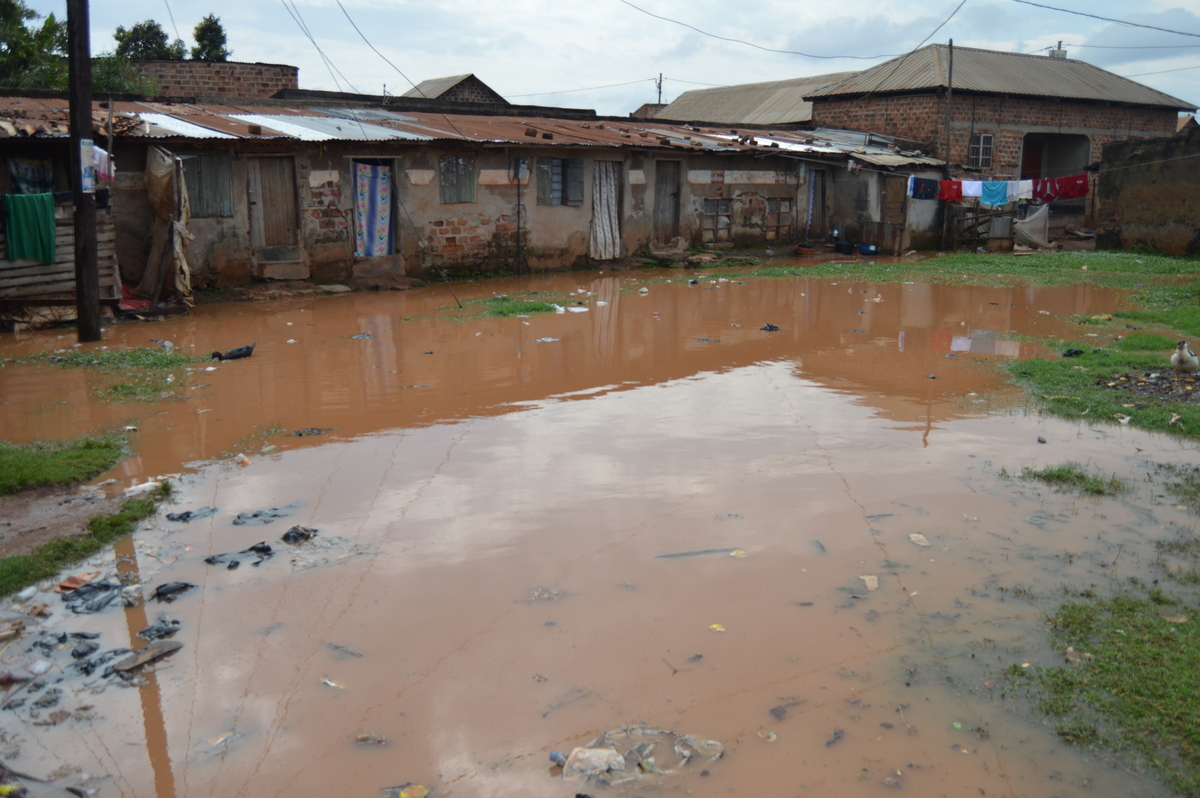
<box><xmin>0</xmin><ymin>436</ymin><xmax>126</xmax><ymax>494</ymax></box>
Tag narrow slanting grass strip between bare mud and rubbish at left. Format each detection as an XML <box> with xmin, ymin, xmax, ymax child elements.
<box><xmin>0</xmin><ymin>482</ymin><xmax>172</xmax><ymax>595</ymax></box>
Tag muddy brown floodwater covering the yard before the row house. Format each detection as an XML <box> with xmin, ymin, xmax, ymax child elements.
<box><xmin>0</xmin><ymin>271</ymin><xmax>1194</xmax><ymax>798</ymax></box>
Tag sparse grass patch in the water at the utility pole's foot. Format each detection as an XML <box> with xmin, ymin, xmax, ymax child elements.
<box><xmin>0</xmin><ymin>347</ymin><xmax>204</xmax><ymax>402</ymax></box>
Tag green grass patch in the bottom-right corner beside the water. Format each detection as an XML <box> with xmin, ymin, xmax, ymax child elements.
<box><xmin>1009</xmin><ymin>592</ymin><xmax>1200</xmax><ymax>796</ymax></box>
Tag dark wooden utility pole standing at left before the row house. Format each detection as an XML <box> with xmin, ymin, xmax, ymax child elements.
<box><xmin>67</xmin><ymin>0</ymin><xmax>100</xmax><ymax>343</ymax></box>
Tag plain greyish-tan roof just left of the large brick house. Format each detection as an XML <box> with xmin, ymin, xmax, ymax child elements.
<box><xmin>655</xmin><ymin>72</ymin><xmax>858</xmax><ymax>125</ymax></box>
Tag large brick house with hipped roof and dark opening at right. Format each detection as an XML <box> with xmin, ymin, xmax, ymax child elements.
<box><xmin>805</xmin><ymin>44</ymin><xmax>1195</xmax><ymax>220</ymax></box>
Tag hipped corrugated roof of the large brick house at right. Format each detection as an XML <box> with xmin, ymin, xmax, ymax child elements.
<box><xmin>806</xmin><ymin>44</ymin><xmax>1195</xmax><ymax>110</ymax></box>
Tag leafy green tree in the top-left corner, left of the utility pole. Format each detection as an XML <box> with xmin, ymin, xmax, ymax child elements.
<box><xmin>0</xmin><ymin>0</ymin><xmax>67</xmax><ymax>89</ymax></box>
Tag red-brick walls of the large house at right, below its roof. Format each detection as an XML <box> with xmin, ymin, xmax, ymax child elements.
<box><xmin>812</xmin><ymin>94</ymin><xmax>1177</xmax><ymax>178</ymax></box>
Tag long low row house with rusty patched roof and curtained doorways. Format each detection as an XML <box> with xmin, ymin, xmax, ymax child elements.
<box><xmin>0</xmin><ymin>92</ymin><xmax>942</xmax><ymax>300</ymax></box>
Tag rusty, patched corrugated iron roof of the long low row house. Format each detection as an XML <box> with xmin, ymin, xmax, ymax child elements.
<box><xmin>0</xmin><ymin>97</ymin><xmax>941</xmax><ymax>166</ymax></box>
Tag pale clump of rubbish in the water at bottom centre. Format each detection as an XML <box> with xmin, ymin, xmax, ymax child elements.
<box><xmin>559</xmin><ymin>724</ymin><xmax>725</xmax><ymax>787</ymax></box>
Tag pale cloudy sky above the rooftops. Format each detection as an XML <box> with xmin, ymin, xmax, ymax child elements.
<box><xmin>26</xmin><ymin>0</ymin><xmax>1200</xmax><ymax>115</ymax></box>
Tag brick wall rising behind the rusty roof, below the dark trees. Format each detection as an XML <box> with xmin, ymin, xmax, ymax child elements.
<box><xmin>133</xmin><ymin>61</ymin><xmax>300</xmax><ymax>97</ymax></box>
